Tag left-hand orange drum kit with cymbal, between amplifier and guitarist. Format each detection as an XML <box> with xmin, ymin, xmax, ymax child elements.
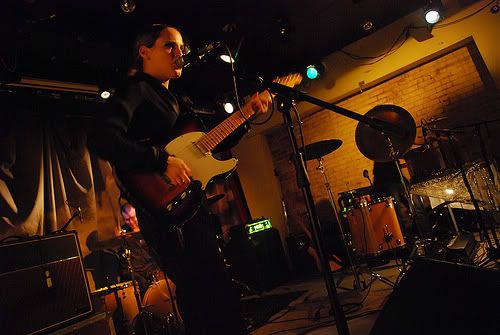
<box><xmin>92</xmin><ymin>232</ymin><xmax>182</xmax><ymax>335</ymax></box>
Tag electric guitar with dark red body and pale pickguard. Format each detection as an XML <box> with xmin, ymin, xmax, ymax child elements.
<box><xmin>119</xmin><ymin>74</ymin><xmax>302</xmax><ymax>219</ymax></box>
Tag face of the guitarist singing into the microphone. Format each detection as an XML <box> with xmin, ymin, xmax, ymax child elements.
<box><xmin>139</xmin><ymin>27</ymin><xmax>184</xmax><ymax>82</ymax></box>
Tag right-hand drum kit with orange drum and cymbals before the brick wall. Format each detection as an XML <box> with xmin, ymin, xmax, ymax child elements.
<box><xmin>302</xmin><ymin>105</ymin><xmax>498</xmax><ymax>287</ymax></box>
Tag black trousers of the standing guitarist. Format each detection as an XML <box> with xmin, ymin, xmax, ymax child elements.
<box><xmin>139</xmin><ymin>208</ymin><xmax>247</xmax><ymax>335</ymax></box>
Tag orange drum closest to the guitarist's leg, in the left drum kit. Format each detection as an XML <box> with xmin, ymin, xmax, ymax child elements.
<box><xmin>142</xmin><ymin>278</ymin><xmax>182</xmax><ymax>324</ymax></box>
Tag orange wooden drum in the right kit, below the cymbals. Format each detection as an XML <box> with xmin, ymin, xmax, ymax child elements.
<box><xmin>347</xmin><ymin>197</ymin><xmax>405</xmax><ymax>255</ymax></box>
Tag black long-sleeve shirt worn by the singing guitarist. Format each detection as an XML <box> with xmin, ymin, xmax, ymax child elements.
<box><xmin>89</xmin><ymin>72</ymin><xmax>181</xmax><ymax>172</ymax></box>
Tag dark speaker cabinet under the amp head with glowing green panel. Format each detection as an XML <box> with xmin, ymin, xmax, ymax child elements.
<box><xmin>224</xmin><ymin>225</ymin><xmax>290</xmax><ymax>290</ymax></box>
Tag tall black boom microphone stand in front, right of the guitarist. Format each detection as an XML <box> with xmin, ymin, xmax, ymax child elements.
<box><xmin>256</xmin><ymin>79</ymin><xmax>404</xmax><ymax>335</ymax></box>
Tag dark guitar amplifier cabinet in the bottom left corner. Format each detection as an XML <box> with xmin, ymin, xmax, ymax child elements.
<box><xmin>0</xmin><ymin>232</ymin><xmax>93</xmax><ymax>335</ymax></box>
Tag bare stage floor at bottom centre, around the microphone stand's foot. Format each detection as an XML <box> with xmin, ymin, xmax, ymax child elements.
<box><xmin>251</xmin><ymin>262</ymin><xmax>400</xmax><ymax>335</ymax></box>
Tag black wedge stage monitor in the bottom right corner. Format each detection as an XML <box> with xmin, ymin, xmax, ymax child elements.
<box><xmin>370</xmin><ymin>259</ymin><xmax>500</xmax><ymax>335</ymax></box>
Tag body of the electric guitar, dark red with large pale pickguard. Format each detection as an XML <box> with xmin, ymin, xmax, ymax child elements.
<box><xmin>120</xmin><ymin>132</ymin><xmax>238</xmax><ymax>219</ymax></box>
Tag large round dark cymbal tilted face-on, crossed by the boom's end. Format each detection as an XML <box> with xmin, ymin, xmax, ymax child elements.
<box><xmin>355</xmin><ymin>105</ymin><xmax>417</xmax><ymax>162</ymax></box>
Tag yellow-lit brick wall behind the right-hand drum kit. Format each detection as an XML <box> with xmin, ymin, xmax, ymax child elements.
<box><xmin>267</xmin><ymin>42</ymin><xmax>500</xmax><ymax>232</ymax></box>
